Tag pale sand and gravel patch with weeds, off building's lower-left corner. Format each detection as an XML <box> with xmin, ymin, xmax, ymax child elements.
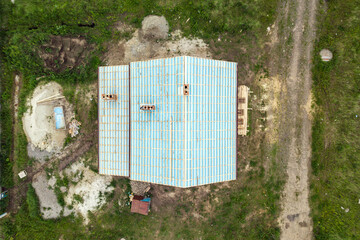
<box><xmin>32</xmin><ymin>159</ymin><xmax>114</xmax><ymax>224</ymax></box>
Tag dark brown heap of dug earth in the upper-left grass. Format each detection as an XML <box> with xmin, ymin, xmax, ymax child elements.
<box><xmin>39</xmin><ymin>36</ymin><xmax>92</xmax><ymax>72</ymax></box>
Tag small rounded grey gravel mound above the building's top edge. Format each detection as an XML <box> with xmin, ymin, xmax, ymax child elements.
<box><xmin>141</xmin><ymin>15</ymin><xmax>169</xmax><ymax>40</ymax></box>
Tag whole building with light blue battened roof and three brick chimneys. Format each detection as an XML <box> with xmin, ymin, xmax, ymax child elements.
<box><xmin>99</xmin><ymin>57</ymin><xmax>237</xmax><ymax>187</ymax></box>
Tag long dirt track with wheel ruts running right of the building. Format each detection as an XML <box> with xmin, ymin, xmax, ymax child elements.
<box><xmin>273</xmin><ymin>0</ymin><xmax>317</xmax><ymax>240</ymax></box>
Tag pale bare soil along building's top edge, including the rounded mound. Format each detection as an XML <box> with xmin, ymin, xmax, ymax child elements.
<box><xmin>105</xmin><ymin>16</ymin><xmax>211</xmax><ymax>65</ymax></box>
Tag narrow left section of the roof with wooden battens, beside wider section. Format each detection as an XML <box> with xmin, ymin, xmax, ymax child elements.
<box><xmin>98</xmin><ymin>65</ymin><xmax>129</xmax><ymax>176</ymax></box>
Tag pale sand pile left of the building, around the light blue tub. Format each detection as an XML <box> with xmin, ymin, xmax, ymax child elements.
<box><xmin>22</xmin><ymin>82</ymin><xmax>75</xmax><ymax>152</ymax></box>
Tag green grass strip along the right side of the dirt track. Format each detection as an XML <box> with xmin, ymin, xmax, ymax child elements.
<box><xmin>311</xmin><ymin>0</ymin><xmax>360</xmax><ymax>239</ymax></box>
